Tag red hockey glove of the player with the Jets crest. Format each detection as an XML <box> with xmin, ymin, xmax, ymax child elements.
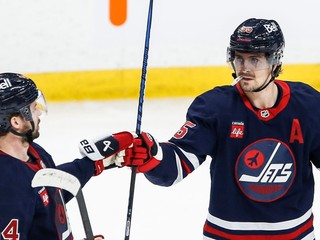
<box><xmin>122</xmin><ymin>132</ymin><xmax>162</xmax><ymax>172</ymax></box>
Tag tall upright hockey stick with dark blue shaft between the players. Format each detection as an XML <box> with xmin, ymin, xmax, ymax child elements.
<box><xmin>124</xmin><ymin>0</ymin><xmax>153</xmax><ymax>240</ymax></box>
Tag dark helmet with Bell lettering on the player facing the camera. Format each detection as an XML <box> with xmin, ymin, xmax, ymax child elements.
<box><xmin>227</xmin><ymin>18</ymin><xmax>285</xmax><ymax>76</ymax></box>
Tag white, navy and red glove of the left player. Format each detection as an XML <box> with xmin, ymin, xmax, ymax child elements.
<box><xmin>79</xmin><ymin>132</ymin><xmax>134</xmax><ymax>175</ymax></box>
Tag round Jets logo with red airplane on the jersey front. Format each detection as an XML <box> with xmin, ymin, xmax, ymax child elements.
<box><xmin>235</xmin><ymin>139</ymin><xmax>296</xmax><ymax>202</ymax></box>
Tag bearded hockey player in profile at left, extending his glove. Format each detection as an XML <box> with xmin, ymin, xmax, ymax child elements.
<box><xmin>0</xmin><ymin>73</ymin><xmax>133</xmax><ymax>240</ymax></box>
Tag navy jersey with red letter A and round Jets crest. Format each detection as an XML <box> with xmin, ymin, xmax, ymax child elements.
<box><xmin>145</xmin><ymin>80</ymin><xmax>320</xmax><ymax>240</ymax></box>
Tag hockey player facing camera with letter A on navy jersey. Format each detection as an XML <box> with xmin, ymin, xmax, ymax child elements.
<box><xmin>115</xmin><ymin>19</ymin><xmax>320</xmax><ymax>240</ymax></box>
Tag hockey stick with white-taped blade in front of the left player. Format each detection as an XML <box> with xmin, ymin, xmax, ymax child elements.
<box><xmin>31</xmin><ymin>168</ymin><xmax>94</xmax><ymax>240</ymax></box>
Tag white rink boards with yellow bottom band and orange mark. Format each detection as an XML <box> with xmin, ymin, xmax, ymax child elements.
<box><xmin>0</xmin><ymin>0</ymin><xmax>320</xmax><ymax>101</ymax></box>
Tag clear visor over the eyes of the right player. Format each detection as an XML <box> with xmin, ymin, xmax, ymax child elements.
<box><xmin>227</xmin><ymin>49</ymin><xmax>281</xmax><ymax>72</ymax></box>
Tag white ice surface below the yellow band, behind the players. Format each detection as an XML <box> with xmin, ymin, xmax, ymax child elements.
<box><xmin>36</xmin><ymin>98</ymin><xmax>320</xmax><ymax>240</ymax></box>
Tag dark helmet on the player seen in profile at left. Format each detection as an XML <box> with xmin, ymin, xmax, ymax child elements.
<box><xmin>0</xmin><ymin>73</ymin><xmax>45</xmax><ymax>133</ymax></box>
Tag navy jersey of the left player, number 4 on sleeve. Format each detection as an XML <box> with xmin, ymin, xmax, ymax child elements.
<box><xmin>0</xmin><ymin>143</ymin><xmax>94</xmax><ymax>240</ymax></box>
